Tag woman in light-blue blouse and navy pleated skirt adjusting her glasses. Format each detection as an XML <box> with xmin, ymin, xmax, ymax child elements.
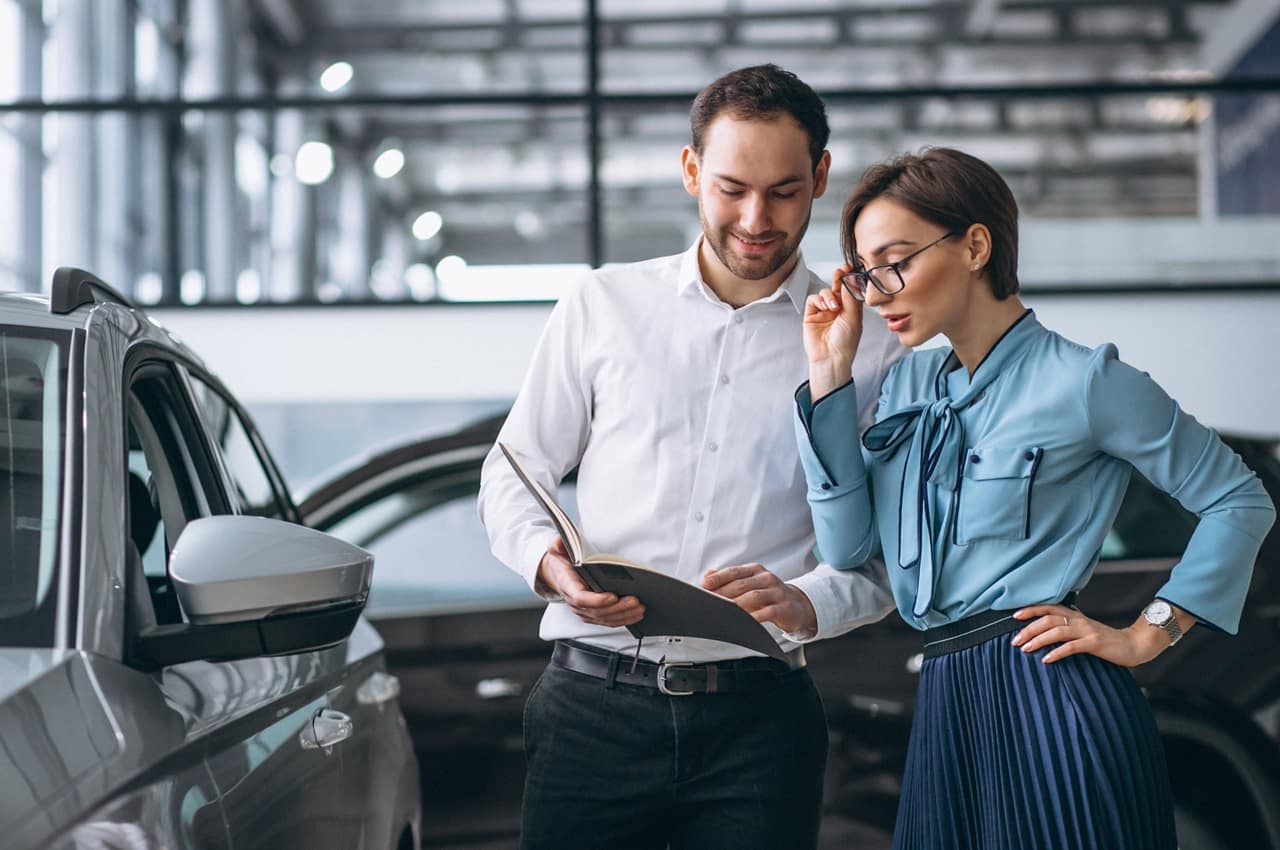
<box><xmin>796</xmin><ymin>148</ymin><xmax>1275</xmax><ymax>850</ymax></box>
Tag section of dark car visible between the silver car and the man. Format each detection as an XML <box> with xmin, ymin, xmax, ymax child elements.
<box><xmin>298</xmin><ymin>420</ymin><xmax>560</xmax><ymax>846</ymax></box>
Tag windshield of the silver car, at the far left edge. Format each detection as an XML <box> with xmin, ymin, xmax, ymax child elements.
<box><xmin>0</xmin><ymin>325</ymin><xmax>68</xmax><ymax>646</ymax></box>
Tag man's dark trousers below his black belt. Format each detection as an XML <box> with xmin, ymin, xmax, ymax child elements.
<box><xmin>521</xmin><ymin>652</ymin><xmax>827</xmax><ymax>850</ymax></box>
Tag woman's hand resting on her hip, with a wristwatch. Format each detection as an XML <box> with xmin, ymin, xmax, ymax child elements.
<box><xmin>1014</xmin><ymin>605</ymin><xmax>1169</xmax><ymax>667</ymax></box>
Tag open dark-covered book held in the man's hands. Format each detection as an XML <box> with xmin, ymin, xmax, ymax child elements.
<box><xmin>498</xmin><ymin>443</ymin><xmax>786</xmax><ymax>659</ymax></box>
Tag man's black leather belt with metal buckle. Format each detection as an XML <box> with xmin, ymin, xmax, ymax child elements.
<box><xmin>552</xmin><ymin>640</ymin><xmax>804</xmax><ymax>696</ymax></box>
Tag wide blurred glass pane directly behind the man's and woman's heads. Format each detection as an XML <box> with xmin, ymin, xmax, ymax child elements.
<box><xmin>602</xmin><ymin>95</ymin><xmax>1280</xmax><ymax>285</ymax></box>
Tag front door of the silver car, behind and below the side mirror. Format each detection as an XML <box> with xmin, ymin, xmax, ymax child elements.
<box><xmin>127</xmin><ymin>352</ymin><xmax>360</xmax><ymax>849</ymax></box>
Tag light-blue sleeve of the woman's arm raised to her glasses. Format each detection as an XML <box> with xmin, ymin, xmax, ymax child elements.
<box><xmin>796</xmin><ymin>381</ymin><xmax>877</xmax><ymax>570</ymax></box>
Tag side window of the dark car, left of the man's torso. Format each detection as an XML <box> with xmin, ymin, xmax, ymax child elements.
<box><xmin>329</xmin><ymin>473</ymin><xmax>577</xmax><ymax>618</ymax></box>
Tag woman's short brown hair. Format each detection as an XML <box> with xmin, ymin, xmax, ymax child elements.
<box><xmin>840</xmin><ymin>147</ymin><xmax>1018</xmax><ymax>301</ymax></box>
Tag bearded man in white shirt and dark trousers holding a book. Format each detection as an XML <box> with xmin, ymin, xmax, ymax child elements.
<box><xmin>480</xmin><ymin>65</ymin><xmax>904</xmax><ymax>850</ymax></box>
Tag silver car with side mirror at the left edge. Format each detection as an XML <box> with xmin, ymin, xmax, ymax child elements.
<box><xmin>0</xmin><ymin>269</ymin><xmax>421</xmax><ymax>850</ymax></box>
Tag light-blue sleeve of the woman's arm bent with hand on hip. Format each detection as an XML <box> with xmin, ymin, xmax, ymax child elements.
<box><xmin>1085</xmin><ymin>344</ymin><xmax>1275</xmax><ymax>635</ymax></box>
